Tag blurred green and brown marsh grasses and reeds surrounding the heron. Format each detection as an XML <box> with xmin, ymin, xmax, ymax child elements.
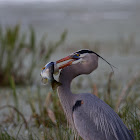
<box><xmin>0</xmin><ymin>25</ymin><xmax>140</xmax><ymax>140</ymax></box>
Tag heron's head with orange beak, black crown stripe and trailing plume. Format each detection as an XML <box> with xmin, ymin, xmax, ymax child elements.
<box><xmin>56</xmin><ymin>50</ymin><xmax>113</xmax><ymax>74</ymax></box>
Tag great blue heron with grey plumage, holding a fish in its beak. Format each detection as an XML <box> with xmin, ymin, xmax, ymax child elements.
<box><xmin>56</xmin><ymin>50</ymin><xmax>134</xmax><ymax>140</ymax></box>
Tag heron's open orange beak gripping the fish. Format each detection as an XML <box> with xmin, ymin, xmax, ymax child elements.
<box><xmin>56</xmin><ymin>55</ymin><xmax>80</xmax><ymax>69</ymax></box>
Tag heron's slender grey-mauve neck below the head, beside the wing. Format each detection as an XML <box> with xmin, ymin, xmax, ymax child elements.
<box><xmin>58</xmin><ymin>67</ymin><xmax>79</xmax><ymax>124</ymax></box>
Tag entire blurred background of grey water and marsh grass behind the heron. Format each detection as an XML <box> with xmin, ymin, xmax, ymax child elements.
<box><xmin>0</xmin><ymin>0</ymin><xmax>140</xmax><ymax>140</ymax></box>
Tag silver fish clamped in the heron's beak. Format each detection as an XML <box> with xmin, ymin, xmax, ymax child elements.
<box><xmin>40</xmin><ymin>62</ymin><xmax>61</xmax><ymax>90</ymax></box>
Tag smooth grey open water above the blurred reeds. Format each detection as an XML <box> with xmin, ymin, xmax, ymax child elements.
<box><xmin>0</xmin><ymin>0</ymin><xmax>140</xmax><ymax>43</ymax></box>
